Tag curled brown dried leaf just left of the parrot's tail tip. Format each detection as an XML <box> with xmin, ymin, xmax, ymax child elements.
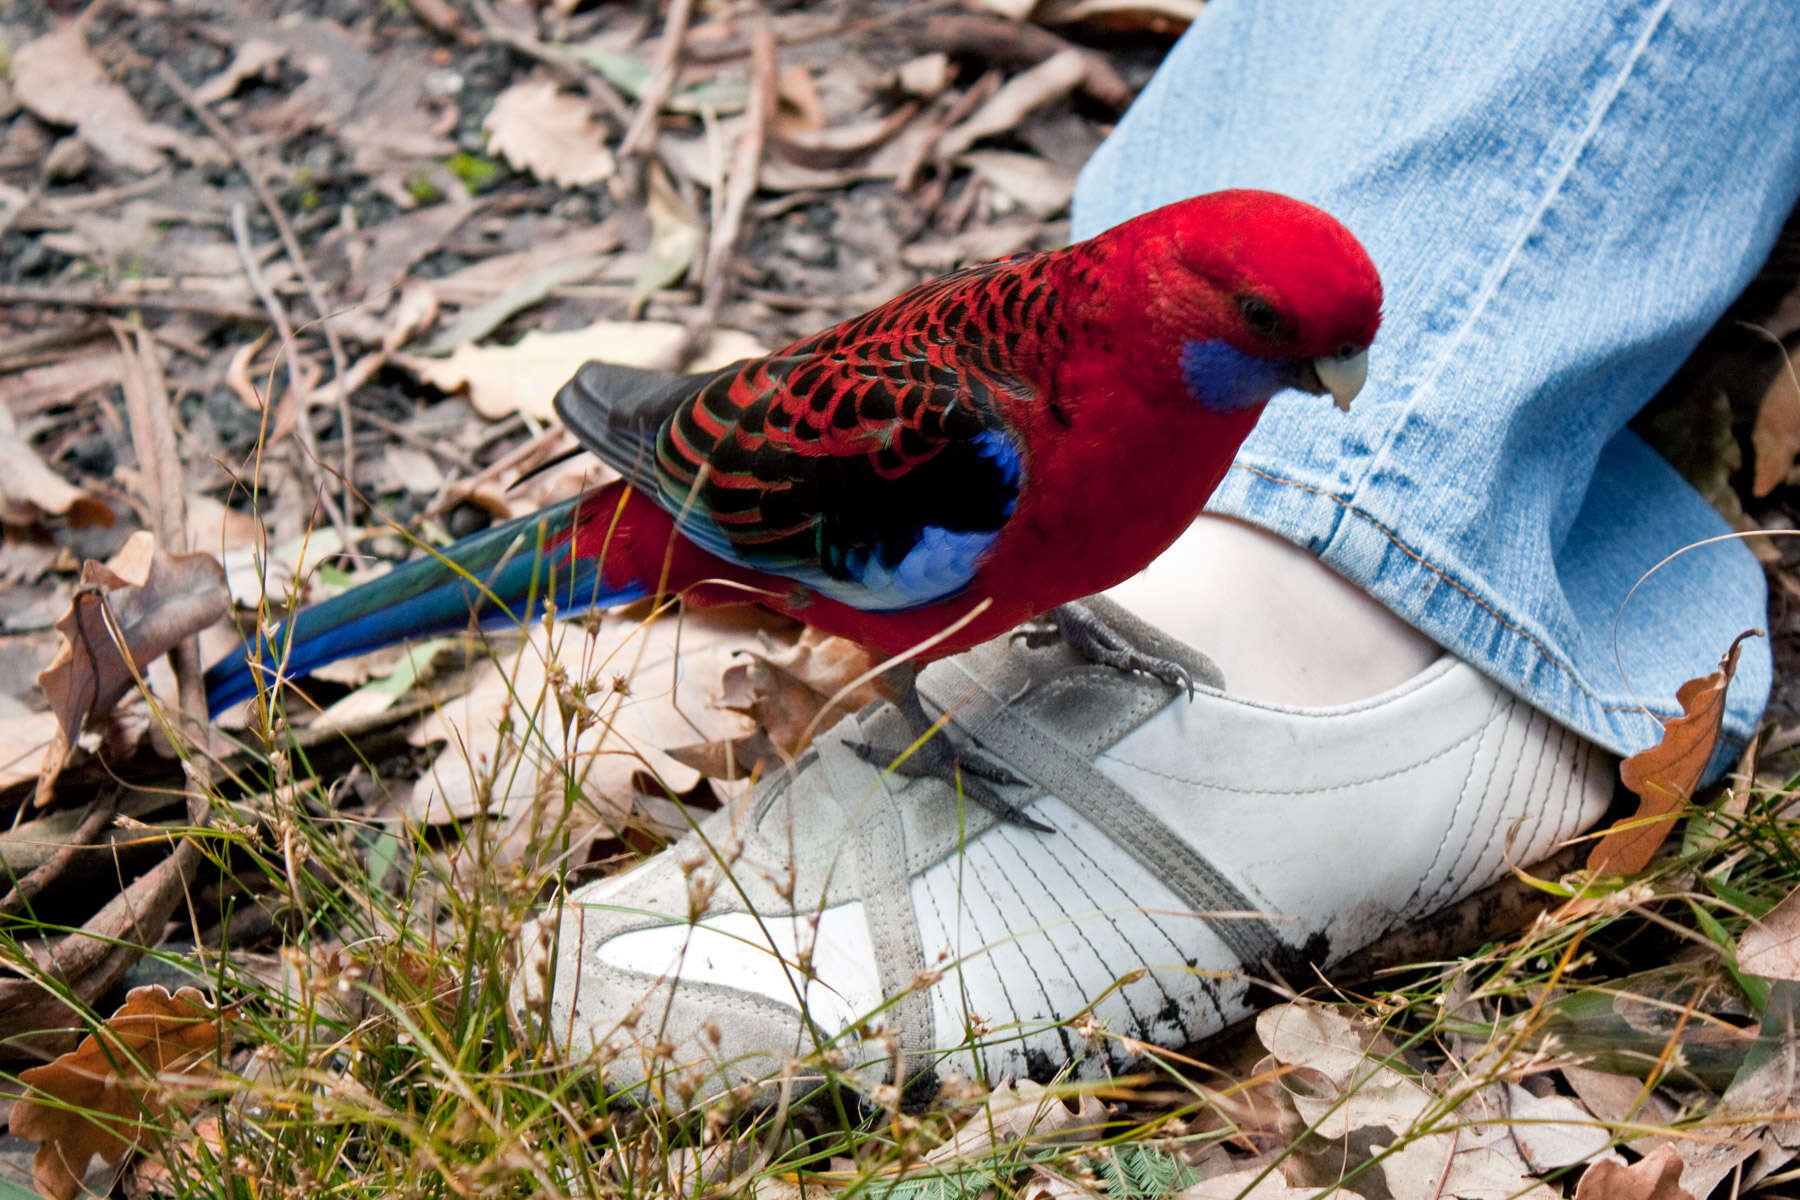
<box><xmin>38</xmin><ymin>531</ymin><xmax>230</xmax><ymax>804</ymax></box>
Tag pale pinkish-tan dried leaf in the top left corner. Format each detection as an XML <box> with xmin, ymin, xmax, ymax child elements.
<box><xmin>13</xmin><ymin>20</ymin><xmax>218</xmax><ymax>171</ymax></box>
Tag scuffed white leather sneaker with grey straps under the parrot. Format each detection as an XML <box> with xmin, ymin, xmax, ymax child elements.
<box><xmin>520</xmin><ymin>601</ymin><xmax>1613</xmax><ymax>1108</ymax></box>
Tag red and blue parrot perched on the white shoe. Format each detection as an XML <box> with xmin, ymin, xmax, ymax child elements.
<box><xmin>207</xmin><ymin>191</ymin><xmax>1381</xmax><ymax>824</ymax></box>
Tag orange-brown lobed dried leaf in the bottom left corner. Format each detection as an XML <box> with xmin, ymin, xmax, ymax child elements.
<box><xmin>13</xmin><ymin>986</ymin><xmax>221</xmax><ymax>1200</ymax></box>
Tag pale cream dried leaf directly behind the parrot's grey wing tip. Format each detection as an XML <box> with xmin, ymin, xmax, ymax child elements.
<box><xmin>394</xmin><ymin>320</ymin><xmax>763</xmax><ymax>421</ymax></box>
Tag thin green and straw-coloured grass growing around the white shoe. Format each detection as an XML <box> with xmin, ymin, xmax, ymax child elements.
<box><xmin>0</xmin><ymin>604</ymin><xmax>1800</xmax><ymax>1200</ymax></box>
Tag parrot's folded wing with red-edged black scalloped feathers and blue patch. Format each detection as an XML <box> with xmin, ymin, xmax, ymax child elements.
<box><xmin>556</xmin><ymin>264</ymin><xmax>1051</xmax><ymax>610</ymax></box>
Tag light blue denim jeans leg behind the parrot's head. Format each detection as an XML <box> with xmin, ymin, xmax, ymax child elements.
<box><xmin>1075</xmin><ymin>0</ymin><xmax>1800</xmax><ymax>768</ymax></box>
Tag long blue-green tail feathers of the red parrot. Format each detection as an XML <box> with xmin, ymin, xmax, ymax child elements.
<box><xmin>205</xmin><ymin>500</ymin><xmax>644</xmax><ymax>714</ymax></box>
